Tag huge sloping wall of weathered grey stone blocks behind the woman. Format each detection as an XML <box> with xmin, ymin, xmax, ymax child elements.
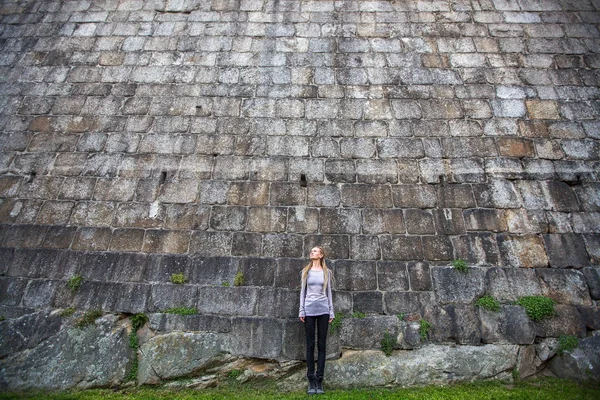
<box><xmin>0</xmin><ymin>0</ymin><xmax>600</xmax><ymax>389</ymax></box>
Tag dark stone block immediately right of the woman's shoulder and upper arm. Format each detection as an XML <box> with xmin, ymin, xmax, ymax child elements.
<box><xmin>332</xmin><ymin>260</ymin><xmax>377</xmax><ymax>291</ymax></box>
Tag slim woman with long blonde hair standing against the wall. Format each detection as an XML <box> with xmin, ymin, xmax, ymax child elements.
<box><xmin>299</xmin><ymin>247</ymin><xmax>335</xmax><ymax>394</ymax></box>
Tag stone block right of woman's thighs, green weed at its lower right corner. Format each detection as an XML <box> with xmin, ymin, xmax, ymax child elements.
<box><xmin>340</xmin><ymin>316</ymin><xmax>398</xmax><ymax>350</ymax></box>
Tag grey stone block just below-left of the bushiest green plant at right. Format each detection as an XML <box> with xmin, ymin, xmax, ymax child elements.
<box><xmin>477</xmin><ymin>305</ymin><xmax>535</xmax><ymax>345</ymax></box>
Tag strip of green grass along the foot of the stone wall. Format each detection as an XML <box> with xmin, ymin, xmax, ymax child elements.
<box><xmin>0</xmin><ymin>378</ymin><xmax>600</xmax><ymax>400</ymax></box>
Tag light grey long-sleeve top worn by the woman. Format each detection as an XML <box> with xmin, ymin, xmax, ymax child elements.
<box><xmin>299</xmin><ymin>270</ymin><xmax>335</xmax><ymax>318</ymax></box>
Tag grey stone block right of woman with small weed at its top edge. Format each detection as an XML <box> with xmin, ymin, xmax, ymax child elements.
<box><xmin>431</xmin><ymin>267</ymin><xmax>485</xmax><ymax>304</ymax></box>
